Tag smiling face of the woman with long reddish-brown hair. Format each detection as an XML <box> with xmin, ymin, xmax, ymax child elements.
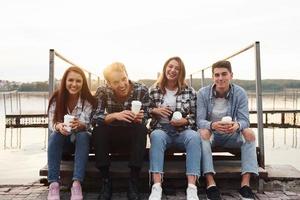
<box><xmin>66</xmin><ymin>71</ymin><xmax>83</xmax><ymax>95</ymax></box>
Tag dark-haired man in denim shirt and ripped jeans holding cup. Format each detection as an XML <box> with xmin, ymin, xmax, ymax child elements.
<box><xmin>197</xmin><ymin>61</ymin><xmax>258</xmax><ymax>199</ymax></box>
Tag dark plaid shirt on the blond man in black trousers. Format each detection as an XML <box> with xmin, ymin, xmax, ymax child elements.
<box><xmin>92</xmin><ymin>81</ymin><xmax>150</xmax><ymax>126</ymax></box>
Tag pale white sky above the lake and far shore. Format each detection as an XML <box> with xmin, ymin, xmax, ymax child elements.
<box><xmin>0</xmin><ymin>0</ymin><xmax>300</xmax><ymax>82</ymax></box>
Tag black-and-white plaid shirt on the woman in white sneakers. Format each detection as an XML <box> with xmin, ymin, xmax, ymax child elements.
<box><xmin>149</xmin><ymin>86</ymin><xmax>197</xmax><ymax>131</ymax></box>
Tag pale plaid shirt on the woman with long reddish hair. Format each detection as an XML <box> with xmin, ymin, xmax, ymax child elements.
<box><xmin>48</xmin><ymin>97</ymin><xmax>92</xmax><ymax>132</ymax></box>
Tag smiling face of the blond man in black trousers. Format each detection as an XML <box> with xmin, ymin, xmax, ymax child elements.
<box><xmin>108</xmin><ymin>71</ymin><xmax>130</xmax><ymax>98</ymax></box>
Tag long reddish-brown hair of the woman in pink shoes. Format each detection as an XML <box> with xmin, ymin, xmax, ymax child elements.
<box><xmin>48</xmin><ymin>66</ymin><xmax>97</xmax><ymax>123</ymax></box>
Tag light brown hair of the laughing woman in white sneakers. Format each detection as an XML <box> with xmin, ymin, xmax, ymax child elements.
<box><xmin>156</xmin><ymin>56</ymin><xmax>186</xmax><ymax>94</ymax></box>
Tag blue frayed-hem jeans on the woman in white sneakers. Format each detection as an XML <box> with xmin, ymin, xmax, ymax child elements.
<box><xmin>149</xmin><ymin>125</ymin><xmax>201</xmax><ymax>177</ymax></box>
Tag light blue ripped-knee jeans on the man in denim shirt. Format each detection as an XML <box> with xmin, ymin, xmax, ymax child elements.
<box><xmin>202</xmin><ymin>132</ymin><xmax>258</xmax><ymax>175</ymax></box>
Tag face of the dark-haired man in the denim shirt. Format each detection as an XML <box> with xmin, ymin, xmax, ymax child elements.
<box><xmin>213</xmin><ymin>67</ymin><xmax>233</xmax><ymax>92</ymax></box>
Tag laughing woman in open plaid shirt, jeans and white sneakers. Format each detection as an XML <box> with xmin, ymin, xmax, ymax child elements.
<box><xmin>149</xmin><ymin>57</ymin><xmax>201</xmax><ymax>200</ymax></box>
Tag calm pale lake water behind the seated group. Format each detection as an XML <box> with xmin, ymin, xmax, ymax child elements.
<box><xmin>0</xmin><ymin>93</ymin><xmax>300</xmax><ymax>184</ymax></box>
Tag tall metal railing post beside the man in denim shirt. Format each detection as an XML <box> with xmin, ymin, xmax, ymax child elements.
<box><xmin>254</xmin><ymin>42</ymin><xmax>265</xmax><ymax>168</ymax></box>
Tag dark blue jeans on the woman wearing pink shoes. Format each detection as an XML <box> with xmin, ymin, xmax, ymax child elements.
<box><xmin>48</xmin><ymin>131</ymin><xmax>90</xmax><ymax>183</ymax></box>
